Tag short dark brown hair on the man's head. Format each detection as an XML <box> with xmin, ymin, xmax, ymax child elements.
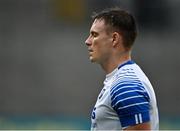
<box><xmin>92</xmin><ymin>8</ymin><xmax>137</xmax><ymax>49</ymax></box>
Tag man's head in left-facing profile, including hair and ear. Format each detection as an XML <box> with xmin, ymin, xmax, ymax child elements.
<box><xmin>86</xmin><ymin>8</ymin><xmax>137</xmax><ymax>63</ymax></box>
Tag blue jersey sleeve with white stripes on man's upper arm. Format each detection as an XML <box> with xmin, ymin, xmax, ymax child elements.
<box><xmin>110</xmin><ymin>80</ymin><xmax>150</xmax><ymax>128</ymax></box>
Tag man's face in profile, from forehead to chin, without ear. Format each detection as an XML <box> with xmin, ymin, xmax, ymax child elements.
<box><xmin>85</xmin><ymin>19</ymin><xmax>112</xmax><ymax>64</ymax></box>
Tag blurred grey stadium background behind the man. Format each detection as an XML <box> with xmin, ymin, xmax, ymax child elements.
<box><xmin>0</xmin><ymin>0</ymin><xmax>180</xmax><ymax>130</ymax></box>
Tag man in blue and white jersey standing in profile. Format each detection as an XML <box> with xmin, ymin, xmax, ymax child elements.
<box><xmin>85</xmin><ymin>8</ymin><xmax>159</xmax><ymax>130</ymax></box>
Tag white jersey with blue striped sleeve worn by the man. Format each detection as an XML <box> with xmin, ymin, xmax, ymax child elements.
<box><xmin>91</xmin><ymin>61</ymin><xmax>159</xmax><ymax>130</ymax></box>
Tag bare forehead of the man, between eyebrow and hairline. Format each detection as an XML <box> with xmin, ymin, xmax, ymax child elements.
<box><xmin>90</xmin><ymin>19</ymin><xmax>106</xmax><ymax>32</ymax></box>
